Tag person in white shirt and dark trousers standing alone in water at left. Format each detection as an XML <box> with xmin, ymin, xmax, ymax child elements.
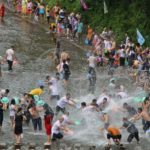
<box><xmin>6</xmin><ymin>46</ymin><xmax>15</xmax><ymax>71</ymax></box>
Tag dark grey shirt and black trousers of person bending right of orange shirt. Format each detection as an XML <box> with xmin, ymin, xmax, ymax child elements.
<box><xmin>123</xmin><ymin>121</ymin><xmax>139</xmax><ymax>142</ymax></box>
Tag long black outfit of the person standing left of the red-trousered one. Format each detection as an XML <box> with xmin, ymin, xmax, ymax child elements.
<box><xmin>14</xmin><ymin>114</ymin><xmax>23</xmax><ymax>135</ymax></box>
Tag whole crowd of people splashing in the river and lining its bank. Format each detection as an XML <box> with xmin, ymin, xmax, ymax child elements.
<box><xmin>0</xmin><ymin>0</ymin><xmax>150</xmax><ymax>149</ymax></box>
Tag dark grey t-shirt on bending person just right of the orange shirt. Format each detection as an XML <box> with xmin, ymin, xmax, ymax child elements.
<box><xmin>123</xmin><ymin>121</ymin><xmax>138</xmax><ymax>133</ymax></box>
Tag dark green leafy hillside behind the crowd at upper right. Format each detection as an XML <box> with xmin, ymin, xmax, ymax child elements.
<box><xmin>47</xmin><ymin>0</ymin><xmax>150</xmax><ymax>46</ymax></box>
